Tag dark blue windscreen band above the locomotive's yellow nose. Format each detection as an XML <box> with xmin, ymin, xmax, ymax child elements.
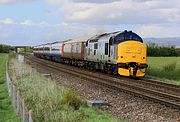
<box><xmin>114</xmin><ymin>31</ymin><xmax>143</xmax><ymax>44</ymax></box>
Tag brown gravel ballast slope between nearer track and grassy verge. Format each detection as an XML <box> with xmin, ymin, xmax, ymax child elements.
<box><xmin>29</xmin><ymin>62</ymin><xmax>180</xmax><ymax>122</ymax></box>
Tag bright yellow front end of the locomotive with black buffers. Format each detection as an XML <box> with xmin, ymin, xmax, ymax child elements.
<box><xmin>117</xmin><ymin>40</ymin><xmax>147</xmax><ymax>77</ymax></box>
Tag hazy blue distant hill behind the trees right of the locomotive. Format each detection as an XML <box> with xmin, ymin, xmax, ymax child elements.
<box><xmin>144</xmin><ymin>37</ymin><xmax>180</xmax><ymax>48</ymax></box>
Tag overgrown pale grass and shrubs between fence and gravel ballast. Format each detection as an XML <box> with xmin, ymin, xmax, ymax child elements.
<box><xmin>10</xmin><ymin>55</ymin><xmax>120</xmax><ymax>122</ymax></box>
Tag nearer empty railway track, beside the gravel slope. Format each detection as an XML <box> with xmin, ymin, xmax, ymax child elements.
<box><xmin>25</xmin><ymin>56</ymin><xmax>180</xmax><ymax>109</ymax></box>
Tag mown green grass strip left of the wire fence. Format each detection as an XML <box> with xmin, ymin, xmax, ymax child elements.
<box><xmin>0</xmin><ymin>53</ymin><xmax>20</xmax><ymax>122</ymax></box>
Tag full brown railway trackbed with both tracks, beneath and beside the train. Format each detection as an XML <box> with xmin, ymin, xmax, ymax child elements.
<box><xmin>25</xmin><ymin>56</ymin><xmax>180</xmax><ymax>110</ymax></box>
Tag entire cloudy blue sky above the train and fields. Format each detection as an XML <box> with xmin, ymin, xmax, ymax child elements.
<box><xmin>0</xmin><ymin>0</ymin><xmax>180</xmax><ymax>46</ymax></box>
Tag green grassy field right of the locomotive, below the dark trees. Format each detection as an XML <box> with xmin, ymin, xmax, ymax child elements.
<box><xmin>147</xmin><ymin>57</ymin><xmax>180</xmax><ymax>83</ymax></box>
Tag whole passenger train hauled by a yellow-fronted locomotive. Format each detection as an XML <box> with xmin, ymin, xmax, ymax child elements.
<box><xmin>33</xmin><ymin>30</ymin><xmax>148</xmax><ymax>77</ymax></box>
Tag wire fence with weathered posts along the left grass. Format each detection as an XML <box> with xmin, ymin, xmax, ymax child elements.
<box><xmin>6</xmin><ymin>62</ymin><xmax>33</xmax><ymax>122</ymax></box>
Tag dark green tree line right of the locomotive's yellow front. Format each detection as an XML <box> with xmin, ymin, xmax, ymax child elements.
<box><xmin>147</xmin><ymin>42</ymin><xmax>180</xmax><ymax>57</ymax></box>
